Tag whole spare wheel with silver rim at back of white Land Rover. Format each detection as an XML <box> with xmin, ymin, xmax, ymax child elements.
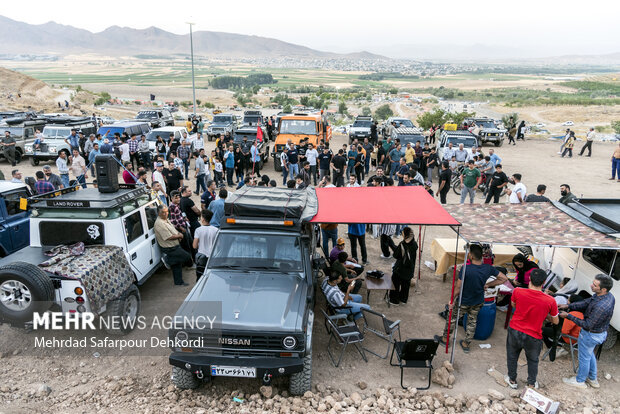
<box><xmin>0</xmin><ymin>262</ymin><xmax>54</xmax><ymax>324</ymax></box>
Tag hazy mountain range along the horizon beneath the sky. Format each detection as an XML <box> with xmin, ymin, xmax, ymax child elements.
<box><xmin>0</xmin><ymin>16</ymin><xmax>387</xmax><ymax>59</ymax></box>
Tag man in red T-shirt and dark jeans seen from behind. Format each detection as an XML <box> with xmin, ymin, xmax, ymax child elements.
<box><xmin>504</xmin><ymin>269</ymin><xmax>560</xmax><ymax>388</ymax></box>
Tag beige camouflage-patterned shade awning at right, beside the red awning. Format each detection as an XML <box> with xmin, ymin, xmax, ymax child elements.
<box><xmin>446</xmin><ymin>203</ymin><xmax>620</xmax><ymax>249</ymax></box>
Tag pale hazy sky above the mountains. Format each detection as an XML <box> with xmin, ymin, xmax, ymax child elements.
<box><xmin>0</xmin><ymin>0</ymin><xmax>620</xmax><ymax>57</ymax></box>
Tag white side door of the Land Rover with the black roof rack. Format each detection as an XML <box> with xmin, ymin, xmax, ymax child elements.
<box><xmin>123</xmin><ymin>209</ymin><xmax>153</xmax><ymax>282</ymax></box>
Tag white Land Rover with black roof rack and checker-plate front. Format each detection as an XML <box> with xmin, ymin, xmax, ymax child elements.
<box><xmin>0</xmin><ymin>170</ymin><xmax>161</xmax><ymax>334</ymax></box>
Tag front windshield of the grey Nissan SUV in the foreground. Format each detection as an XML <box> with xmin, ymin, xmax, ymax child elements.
<box><xmin>209</xmin><ymin>232</ymin><xmax>302</xmax><ymax>271</ymax></box>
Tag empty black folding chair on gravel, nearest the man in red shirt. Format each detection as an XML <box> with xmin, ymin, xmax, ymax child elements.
<box><xmin>390</xmin><ymin>339</ymin><xmax>439</xmax><ymax>390</ymax></box>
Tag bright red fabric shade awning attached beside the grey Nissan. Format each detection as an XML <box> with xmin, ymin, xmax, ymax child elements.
<box><xmin>311</xmin><ymin>186</ymin><xmax>460</xmax><ymax>226</ymax></box>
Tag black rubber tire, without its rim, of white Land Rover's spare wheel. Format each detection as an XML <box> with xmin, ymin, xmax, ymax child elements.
<box><xmin>0</xmin><ymin>262</ymin><xmax>54</xmax><ymax>324</ymax></box>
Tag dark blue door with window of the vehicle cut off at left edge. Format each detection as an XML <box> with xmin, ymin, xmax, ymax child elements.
<box><xmin>0</xmin><ymin>188</ymin><xmax>30</xmax><ymax>254</ymax></box>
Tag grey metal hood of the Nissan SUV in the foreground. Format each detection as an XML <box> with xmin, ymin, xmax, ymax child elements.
<box><xmin>177</xmin><ymin>269</ymin><xmax>307</xmax><ymax>332</ymax></box>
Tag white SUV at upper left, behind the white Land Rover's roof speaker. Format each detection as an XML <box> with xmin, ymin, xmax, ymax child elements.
<box><xmin>24</xmin><ymin>117</ymin><xmax>97</xmax><ymax>165</ymax></box>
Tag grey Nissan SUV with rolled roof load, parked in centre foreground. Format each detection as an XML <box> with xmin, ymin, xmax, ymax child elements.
<box><xmin>169</xmin><ymin>187</ymin><xmax>320</xmax><ymax>395</ymax></box>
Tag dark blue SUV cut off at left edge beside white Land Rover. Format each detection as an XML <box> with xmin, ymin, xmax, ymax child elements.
<box><xmin>0</xmin><ymin>181</ymin><xmax>32</xmax><ymax>257</ymax></box>
